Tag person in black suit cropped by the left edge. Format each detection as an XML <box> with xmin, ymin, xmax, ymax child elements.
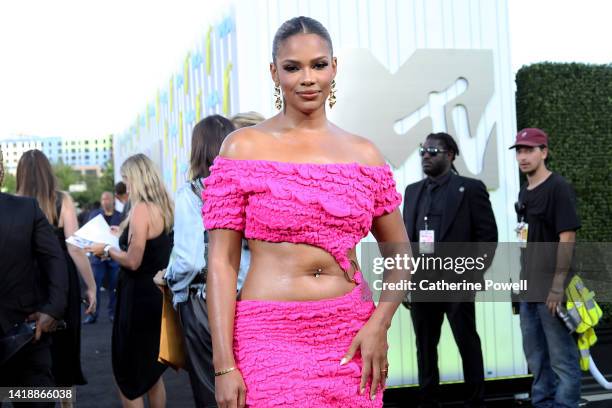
<box><xmin>0</xmin><ymin>150</ymin><xmax>68</xmax><ymax>407</ymax></box>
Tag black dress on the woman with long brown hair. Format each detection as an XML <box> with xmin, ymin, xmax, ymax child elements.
<box><xmin>51</xmin><ymin>193</ymin><xmax>87</xmax><ymax>387</ymax></box>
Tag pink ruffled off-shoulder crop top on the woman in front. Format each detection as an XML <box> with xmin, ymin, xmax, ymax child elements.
<box><xmin>202</xmin><ymin>156</ymin><xmax>402</xmax><ymax>271</ymax></box>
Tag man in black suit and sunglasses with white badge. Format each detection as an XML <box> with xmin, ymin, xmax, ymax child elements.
<box><xmin>403</xmin><ymin>133</ymin><xmax>497</xmax><ymax>408</ymax></box>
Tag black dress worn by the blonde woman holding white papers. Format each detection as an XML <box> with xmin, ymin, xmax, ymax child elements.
<box><xmin>112</xmin><ymin>228</ymin><xmax>172</xmax><ymax>400</ymax></box>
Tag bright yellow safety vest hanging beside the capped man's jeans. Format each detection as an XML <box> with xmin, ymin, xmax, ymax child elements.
<box><xmin>565</xmin><ymin>275</ymin><xmax>603</xmax><ymax>371</ymax></box>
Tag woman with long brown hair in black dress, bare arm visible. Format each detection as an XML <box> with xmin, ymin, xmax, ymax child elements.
<box><xmin>16</xmin><ymin>150</ymin><xmax>96</xmax><ymax>396</ymax></box>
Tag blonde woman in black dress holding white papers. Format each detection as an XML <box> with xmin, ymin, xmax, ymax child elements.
<box><xmin>86</xmin><ymin>154</ymin><xmax>174</xmax><ymax>408</ymax></box>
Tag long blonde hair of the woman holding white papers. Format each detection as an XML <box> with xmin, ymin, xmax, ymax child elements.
<box><xmin>121</xmin><ymin>153</ymin><xmax>174</xmax><ymax>233</ymax></box>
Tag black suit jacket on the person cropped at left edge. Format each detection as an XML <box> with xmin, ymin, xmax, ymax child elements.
<box><xmin>0</xmin><ymin>193</ymin><xmax>68</xmax><ymax>333</ymax></box>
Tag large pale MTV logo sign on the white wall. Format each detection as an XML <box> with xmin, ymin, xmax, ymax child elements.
<box><xmin>330</xmin><ymin>49</ymin><xmax>499</xmax><ymax>189</ymax></box>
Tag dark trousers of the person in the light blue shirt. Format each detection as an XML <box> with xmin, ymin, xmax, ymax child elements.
<box><xmin>178</xmin><ymin>291</ymin><xmax>217</xmax><ymax>408</ymax></box>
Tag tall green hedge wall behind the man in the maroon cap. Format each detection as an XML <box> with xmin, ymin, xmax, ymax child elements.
<box><xmin>516</xmin><ymin>62</ymin><xmax>612</xmax><ymax>324</ymax></box>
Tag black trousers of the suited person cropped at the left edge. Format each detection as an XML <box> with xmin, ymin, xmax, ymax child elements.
<box><xmin>0</xmin><ymin>334</ymin><xmax>55</xmax><ymax>408</ymax></box>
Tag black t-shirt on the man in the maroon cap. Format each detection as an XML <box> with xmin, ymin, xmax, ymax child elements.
<box><xmin>519</xmin><ymin>173</ymin><xmax>580</xmax><ymax>302</ymax></box>
